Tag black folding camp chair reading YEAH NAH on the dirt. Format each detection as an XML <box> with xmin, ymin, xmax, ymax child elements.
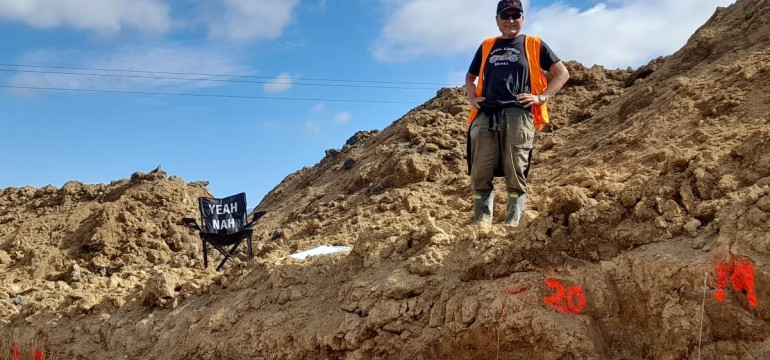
<box><xmin>182</xmin><ymin>193</ymin><xmax>265</xmax><ymax>271</ymax></box>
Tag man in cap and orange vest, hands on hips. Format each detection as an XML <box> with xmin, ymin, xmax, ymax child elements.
<box><xmin>465</xmin><ymin>0</ymin><xmax>569</xmax><ymax>226</ymax></box>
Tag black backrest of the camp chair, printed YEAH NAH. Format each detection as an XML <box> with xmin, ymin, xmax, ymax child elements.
<box><xmin>198</xmin><ymin>193</ymin><xmax>246</xmax><ymax>235</ymax></box>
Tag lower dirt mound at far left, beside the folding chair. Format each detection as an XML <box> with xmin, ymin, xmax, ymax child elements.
<box><xmin>0</xmin><ymin>168</ymin><xmax>216</xmax><ymax>322</ymax></box>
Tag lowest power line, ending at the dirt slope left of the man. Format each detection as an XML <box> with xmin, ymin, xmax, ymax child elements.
<box><xmin>0</xmin><ymin>85</ymin><xmax>418</xmax><ymax>105</ymax></box>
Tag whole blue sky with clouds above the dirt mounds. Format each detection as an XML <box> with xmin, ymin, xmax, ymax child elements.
<box><xmin>0</xmin><ymin>0</ymin><xmax>734</xmax><ymax>206</ymax></box>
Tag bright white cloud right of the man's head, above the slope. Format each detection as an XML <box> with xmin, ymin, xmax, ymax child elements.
<box><xmin>525</xmin><ymin>0</ymin><xmax>734</xmax><ymax>68</ymax></box>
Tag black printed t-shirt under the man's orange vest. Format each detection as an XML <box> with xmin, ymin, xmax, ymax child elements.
<box><xmin>468</xmin><ymin>34</ymin><xmax>561</xmax><ymax>106</ymax></box>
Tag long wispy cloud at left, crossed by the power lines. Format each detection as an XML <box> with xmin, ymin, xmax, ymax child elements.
<box><xmin>8</xmin><ymin>45</ymin><xmax>247</xmax><ymax>92</ymax></box>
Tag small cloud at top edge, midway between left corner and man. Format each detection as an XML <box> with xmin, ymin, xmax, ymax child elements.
<box><xmin>209</xmin><ymin>0</ymin><xmax>299</xmax><ymax>41</ymax></box>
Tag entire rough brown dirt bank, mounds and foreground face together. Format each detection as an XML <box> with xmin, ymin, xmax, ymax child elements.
<box><xmin>0</xmin><ymin>0</ymin><xmax>770</xmax><ymax>359</ymax></box>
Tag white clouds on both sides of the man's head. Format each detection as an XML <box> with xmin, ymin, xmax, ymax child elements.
<box><xmin>373</xmin><ymin>0</ymin><xmax>735</xmax><ymax>67</ymax></box>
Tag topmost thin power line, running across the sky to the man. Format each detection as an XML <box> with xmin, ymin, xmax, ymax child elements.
<box><xmin>0</xmin><ymin>63</ymin><xmax>462</xmax><ymax>86</ymax></box>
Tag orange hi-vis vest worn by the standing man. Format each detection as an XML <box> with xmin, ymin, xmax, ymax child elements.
<box><xmin>468</xmin><ymin>35</ymin><xmax>550</xmax><ymax>130</ymax></box>
